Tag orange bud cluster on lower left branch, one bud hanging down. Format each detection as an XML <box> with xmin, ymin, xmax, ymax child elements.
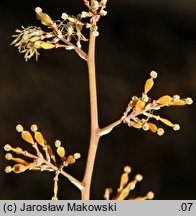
<box><xmin>4</xmin><ymin>124</ymin><xmax>80</xmax><ymax>199</ymax></box>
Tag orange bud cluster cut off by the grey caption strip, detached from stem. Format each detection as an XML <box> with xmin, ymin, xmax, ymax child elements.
<box><xmin>104</xmin><ymin>166</ymin><xmax>154</xmax><ymax>200</ymax></box>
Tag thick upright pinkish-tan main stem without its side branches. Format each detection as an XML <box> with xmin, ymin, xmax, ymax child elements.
<box><xmin>81</xmin><ymin>32</ymin><xmax>100</xmax><ymax>200</ymax></box>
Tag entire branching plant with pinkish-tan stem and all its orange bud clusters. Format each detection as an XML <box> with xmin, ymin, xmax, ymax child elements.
<box><xmin>4</xmin><ymin>0</ymin><xmax>193</xmax><ymax>200</ymax></box>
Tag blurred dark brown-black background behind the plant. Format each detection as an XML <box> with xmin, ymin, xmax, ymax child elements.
<box><xmin>0</xmin><ymin>0</ymin><xmax>196</xmax><ymax>199</ymax></box>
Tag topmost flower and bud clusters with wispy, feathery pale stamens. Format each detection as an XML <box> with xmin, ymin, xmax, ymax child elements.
<box><xmin>11</xmin><ymin>0</ymin><xmax>107</xmax><ymax>61</ymax></box>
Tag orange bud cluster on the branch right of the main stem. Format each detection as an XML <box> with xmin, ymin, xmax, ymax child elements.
<box><xmin>122</xmin><ymin>71</ymin><xmax>193</xmax><ymax>136</ymax></box>
